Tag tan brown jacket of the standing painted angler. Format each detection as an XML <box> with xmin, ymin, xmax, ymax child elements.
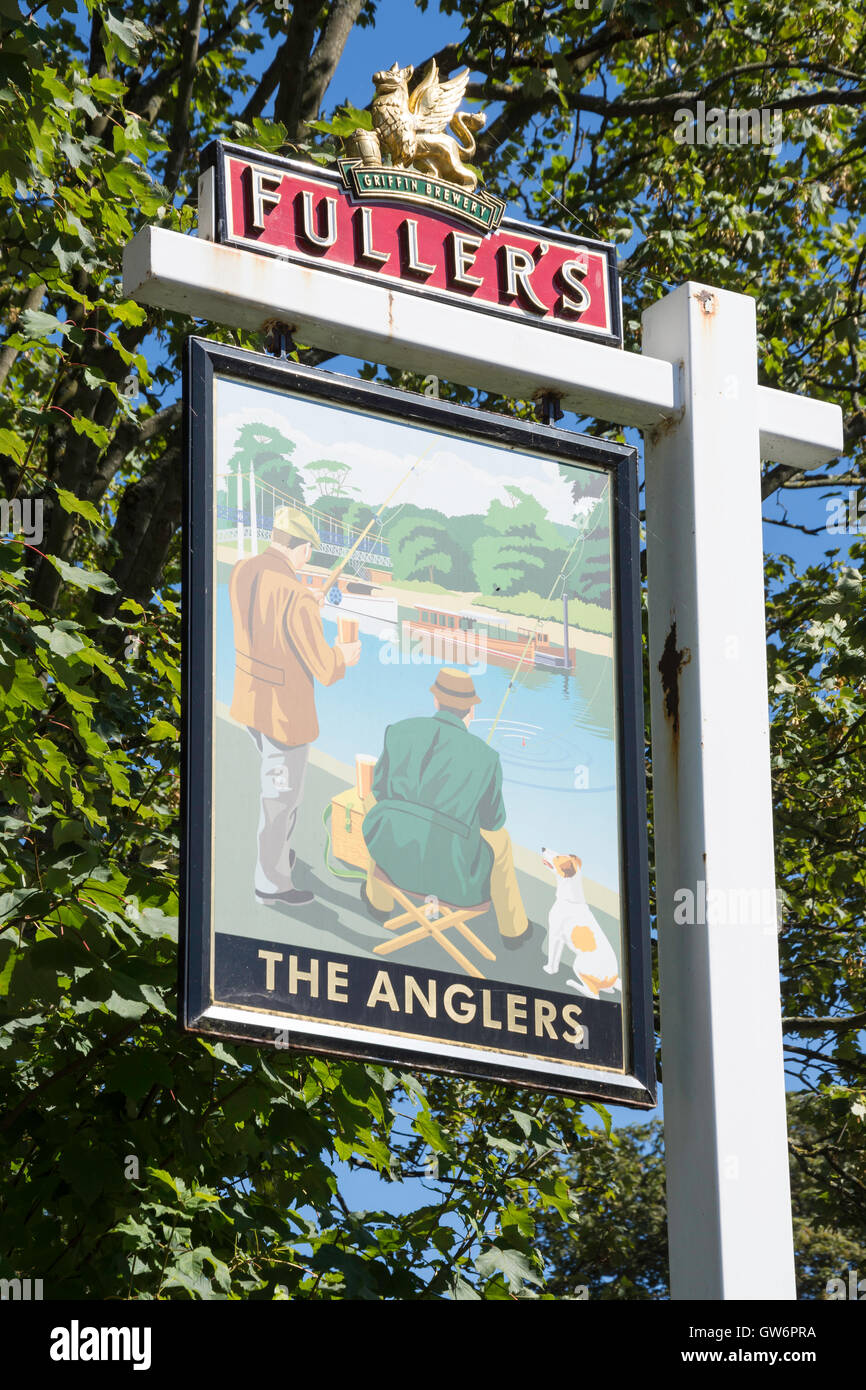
<box><xmin>229</xmin><ymin>545</ymin><xmax>346</xmax><ymax>746</ymax></box>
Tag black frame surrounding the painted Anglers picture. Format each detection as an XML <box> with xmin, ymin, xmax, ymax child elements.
<box><xmin>178</xmin><ymin>336</ymin><xmax>656</xmax><ymax>1109</ymax></box>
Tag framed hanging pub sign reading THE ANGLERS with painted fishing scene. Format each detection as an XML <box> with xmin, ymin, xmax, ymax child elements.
<box><xmin>181</xmin><ymin>338</ymin><xmax>655</xmax><ymax>1106</ymax></box>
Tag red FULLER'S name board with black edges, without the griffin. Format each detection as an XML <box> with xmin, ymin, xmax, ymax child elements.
<box><xmin>203</xmin><ymin>142</ymin><xmax>621</xmax><ymax>346</ymax></box>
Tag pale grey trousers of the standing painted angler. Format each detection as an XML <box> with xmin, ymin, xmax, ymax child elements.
<box><xmin>249</xmin><ymin>728</ymin><xmax>310</xmax><ymax>892</ymax></box>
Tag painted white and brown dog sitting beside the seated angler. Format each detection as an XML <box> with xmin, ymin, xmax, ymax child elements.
<box><xmin>541</xmin><ymin>849</ymin><xmax>621</xmax><ymax>999</ymax></box>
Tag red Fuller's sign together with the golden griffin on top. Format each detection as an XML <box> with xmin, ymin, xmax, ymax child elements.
<box><xmin>199</xmin><ymin>64</ymin><xmax>621</xmax><ymax>346</ymax></box>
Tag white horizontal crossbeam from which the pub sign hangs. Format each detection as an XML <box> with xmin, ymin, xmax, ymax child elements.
<box><xmin>124</xmin><ymin>227</ymin><xmax>842</xmax><ymax>468</ymax></box>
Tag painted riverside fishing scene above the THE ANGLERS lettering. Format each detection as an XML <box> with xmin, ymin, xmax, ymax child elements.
<box><xmin>213</xmin><ymin>379</ymin><xmax>623</xmax><ymax>1028</ymax></box>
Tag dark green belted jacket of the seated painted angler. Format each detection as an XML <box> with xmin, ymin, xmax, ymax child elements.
<box><xmin>363</xmin><ymin>709</ymin><xmax>506</xmax><ymax>908</ymax></box>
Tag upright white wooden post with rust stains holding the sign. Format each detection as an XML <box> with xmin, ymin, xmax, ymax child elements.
<box><xmin>644</xmin><ymin>284</ymin><xmax>795</xmax><ymax>1300</ymax></box>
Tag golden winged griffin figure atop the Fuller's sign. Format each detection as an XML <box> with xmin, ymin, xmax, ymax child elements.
<box><xmin>371</xmin><ymin>58</ymin><xmax>485</xmax><ymax>192</ymax></box>
